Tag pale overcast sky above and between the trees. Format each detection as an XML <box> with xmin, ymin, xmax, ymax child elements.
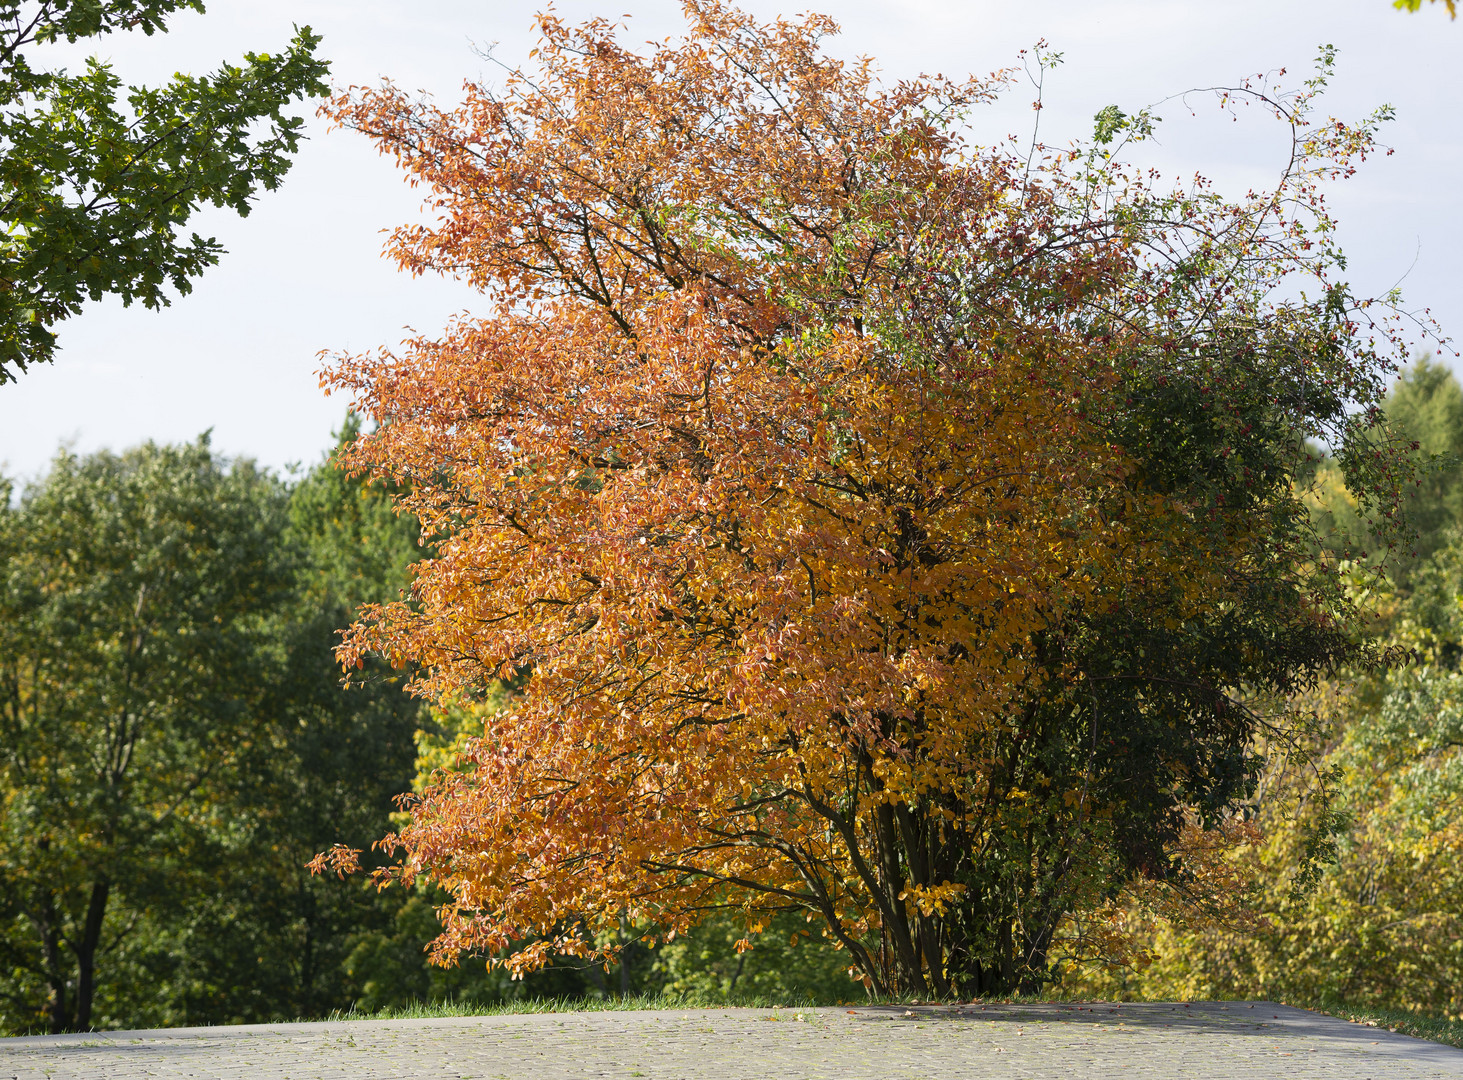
<box><xmin>0</xmin><ymin>0</ymin><xmax>1463</xmax><ymax>479</ymax></box>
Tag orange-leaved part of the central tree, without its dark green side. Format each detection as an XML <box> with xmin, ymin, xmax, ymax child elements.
<box><xmin>317</xmin><ymin>0</ymin><xmax>1410</xmax><ymax>992</ymax></box>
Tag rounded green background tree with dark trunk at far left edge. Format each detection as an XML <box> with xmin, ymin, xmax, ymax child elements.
<box><xmin>0</xmin><ymin>439</ymin><xmax>290</xmax><ymax>1032</ymax></box>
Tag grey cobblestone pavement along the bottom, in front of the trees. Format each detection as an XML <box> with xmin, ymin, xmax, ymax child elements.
<box><xmin>0</xmin><ymin>1002</ymin><xmax>1463</xmax><ymax>1080</ymax></box>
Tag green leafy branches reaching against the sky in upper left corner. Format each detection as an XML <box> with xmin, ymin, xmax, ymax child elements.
<box><xmin>0</xmin><ymin>0</ymin><xmax>328</xmax><ymax>383</ymax></box>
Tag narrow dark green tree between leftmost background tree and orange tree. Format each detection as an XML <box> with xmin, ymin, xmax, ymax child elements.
<box><xmin>188</xmin><ymin>417</ymin><xmax>426</xmax><ymax>1020</ymax></box>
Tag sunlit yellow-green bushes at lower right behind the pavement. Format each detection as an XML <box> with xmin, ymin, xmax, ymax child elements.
<box><xmin>1083</xmin><ymin>669</ymin><xmax>1463</xmax><ymax>1016</ymax></box>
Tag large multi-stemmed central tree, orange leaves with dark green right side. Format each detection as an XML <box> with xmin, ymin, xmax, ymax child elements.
<box><xmin>316</xmin><ymin>0</ymin><xmax>1416</xmax><ymax>994</ymax></box>
